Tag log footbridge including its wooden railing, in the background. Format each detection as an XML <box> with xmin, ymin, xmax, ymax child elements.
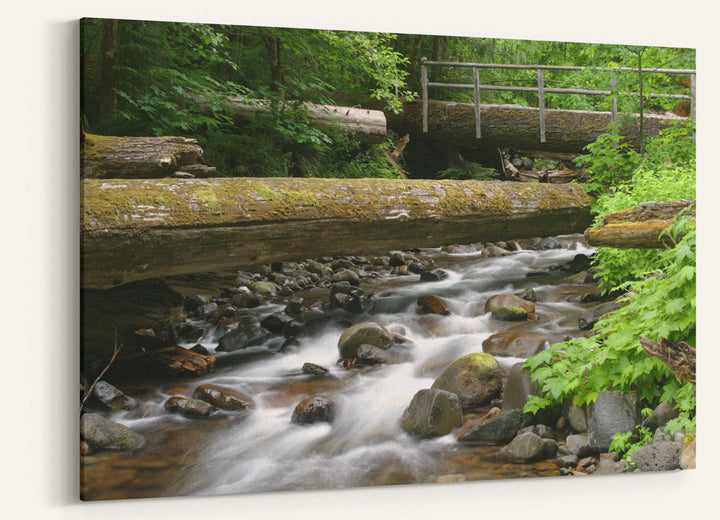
<box><xmin>388</xmin><ymin>58</ymin><xmax>696</xmax><ymax>169</ymax></box>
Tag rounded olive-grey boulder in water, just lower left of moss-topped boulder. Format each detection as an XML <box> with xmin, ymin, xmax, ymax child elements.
<box><xmin>402</xmin><ymin>389</ymin><xmax>462</xmax><ymax>439</ymax></box>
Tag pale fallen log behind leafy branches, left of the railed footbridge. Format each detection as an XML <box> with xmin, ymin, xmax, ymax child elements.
<box><xmin>221</xmin><ymin>97</ymin><xmax>387</xmax><ymax>143</ymax></box>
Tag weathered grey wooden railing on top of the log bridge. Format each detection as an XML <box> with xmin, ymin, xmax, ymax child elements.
<box><xmin>420</xmin><ymin>58</ymin><xmax>696</xmax><ymax>143</ymax></box>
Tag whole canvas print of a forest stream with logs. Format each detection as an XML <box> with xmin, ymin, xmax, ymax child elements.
<box><xmin>79</xmin><ymin>18</ymin><xmax>697</xmax><ymax>500</ymax></box>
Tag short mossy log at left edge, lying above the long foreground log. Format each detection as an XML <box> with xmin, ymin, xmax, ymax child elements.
<box><xmin>80</xmin><ymin>134</ymin><xmax>208</xmax><ymax>179</ymax></box>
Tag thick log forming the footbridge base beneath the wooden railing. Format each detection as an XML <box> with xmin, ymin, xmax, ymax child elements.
<box><xmin>388</xmin><ymin>101</ymin><xmax>683</xmax><ymax>156</ymax></box>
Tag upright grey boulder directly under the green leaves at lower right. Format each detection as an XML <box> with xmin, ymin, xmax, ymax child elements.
<box><xmin>588</xmin><ymin>390</ymin><xmax>640</xmax><ymax>451</ymax></box>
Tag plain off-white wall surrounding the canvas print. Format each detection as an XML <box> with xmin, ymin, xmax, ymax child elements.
<box><xmin>0</xmin><ymin>0</ymin><xmax>720</xmax><ymax>520</ymax></box>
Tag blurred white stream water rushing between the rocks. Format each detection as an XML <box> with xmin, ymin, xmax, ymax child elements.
<box><xmin>81</xmin><ymin>235</ymin><xmax>592</xmax><ymax>499</ymax></box>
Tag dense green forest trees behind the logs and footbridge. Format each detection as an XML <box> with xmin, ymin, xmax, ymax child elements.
<box><xmin>81</xmin><ymin>19</ymin><xmax>695</xmax><ymax>178</ymax></box>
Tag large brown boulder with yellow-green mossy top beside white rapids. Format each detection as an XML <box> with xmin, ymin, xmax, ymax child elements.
<box><xmin>432</xmin><ymin>352</ymin><xmax>502</xmax><ymax>408</ymax></box>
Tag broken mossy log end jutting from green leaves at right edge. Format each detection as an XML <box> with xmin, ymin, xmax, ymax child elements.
<box><xmin>585</xmin><ymin>200</ymin><xmax>695</xmax><ymax>249</ymax></box>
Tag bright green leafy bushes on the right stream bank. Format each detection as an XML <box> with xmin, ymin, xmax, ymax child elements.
<box><xmin>525</xmin><ymin>216</ymin><xmax>696</xmax><ymax>456</ymax></box>
